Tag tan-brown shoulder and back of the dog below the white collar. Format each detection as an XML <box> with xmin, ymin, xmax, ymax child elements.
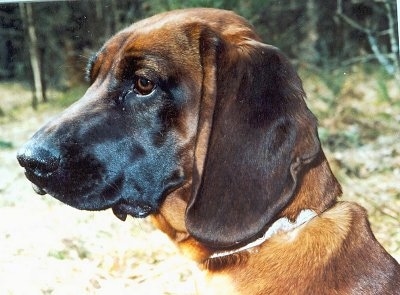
<box><xmin>198</xmin><ymin>203</ymin><xmax>399</xmax><ymax>294</ymax></box>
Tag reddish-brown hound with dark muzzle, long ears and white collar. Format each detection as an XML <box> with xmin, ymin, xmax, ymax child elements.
<box><xmin>17</xmin><ymin>9</ymin><xmax>400</xmax><ymax>295</ymax></box>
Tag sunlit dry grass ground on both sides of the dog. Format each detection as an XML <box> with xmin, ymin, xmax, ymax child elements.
<box><xmin>0</xmin><ymin>72</ymin><xmax>400</xmax><ymax>295</ymax></box>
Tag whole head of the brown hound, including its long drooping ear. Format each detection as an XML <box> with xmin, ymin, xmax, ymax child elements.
<box><xmin>18</xmin><ymin>9</ymin><xmax>337</xmax><ymax>248</ymax></box>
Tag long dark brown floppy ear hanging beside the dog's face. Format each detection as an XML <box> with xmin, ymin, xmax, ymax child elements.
<box><xmin>186</xmin><ymin>41</ymin><xmax>320</xmax><ymax>248</ymax></box>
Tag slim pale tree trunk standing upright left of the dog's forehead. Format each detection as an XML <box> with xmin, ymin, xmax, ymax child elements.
<box><xmin>20</xmin><ymin>3</ymin><xmax>46</xmax><ymax>109</ymax></box>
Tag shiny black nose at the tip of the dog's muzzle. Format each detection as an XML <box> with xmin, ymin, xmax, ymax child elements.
<box><xmin>17</xmin><ymin>142</ymin><xmax>60</xmax><ymax>177</ymax></box>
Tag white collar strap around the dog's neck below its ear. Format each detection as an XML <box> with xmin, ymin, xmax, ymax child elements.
<box><xmin>210</xmin><ymin>209</ymin><xmax>317</xmax><ymax>259</ymax></box>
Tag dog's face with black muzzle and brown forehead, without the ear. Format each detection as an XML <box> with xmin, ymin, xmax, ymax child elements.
<box><xmin>18</xmin><ymin>11</ymin><xmax>206</xmax><ymax>219</ymax></box>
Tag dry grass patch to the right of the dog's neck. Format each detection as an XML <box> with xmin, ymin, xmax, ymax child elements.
<box><xmin>304</xmin><ymin>69</ymin><xmax>400</xmax><ymax>261</ymax></box>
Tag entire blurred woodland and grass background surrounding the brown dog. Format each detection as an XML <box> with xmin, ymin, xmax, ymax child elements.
<box><xmin>0</xmin><ymin>0</ymin><xmax>400</xmax><ymax>295</ymax></box>
